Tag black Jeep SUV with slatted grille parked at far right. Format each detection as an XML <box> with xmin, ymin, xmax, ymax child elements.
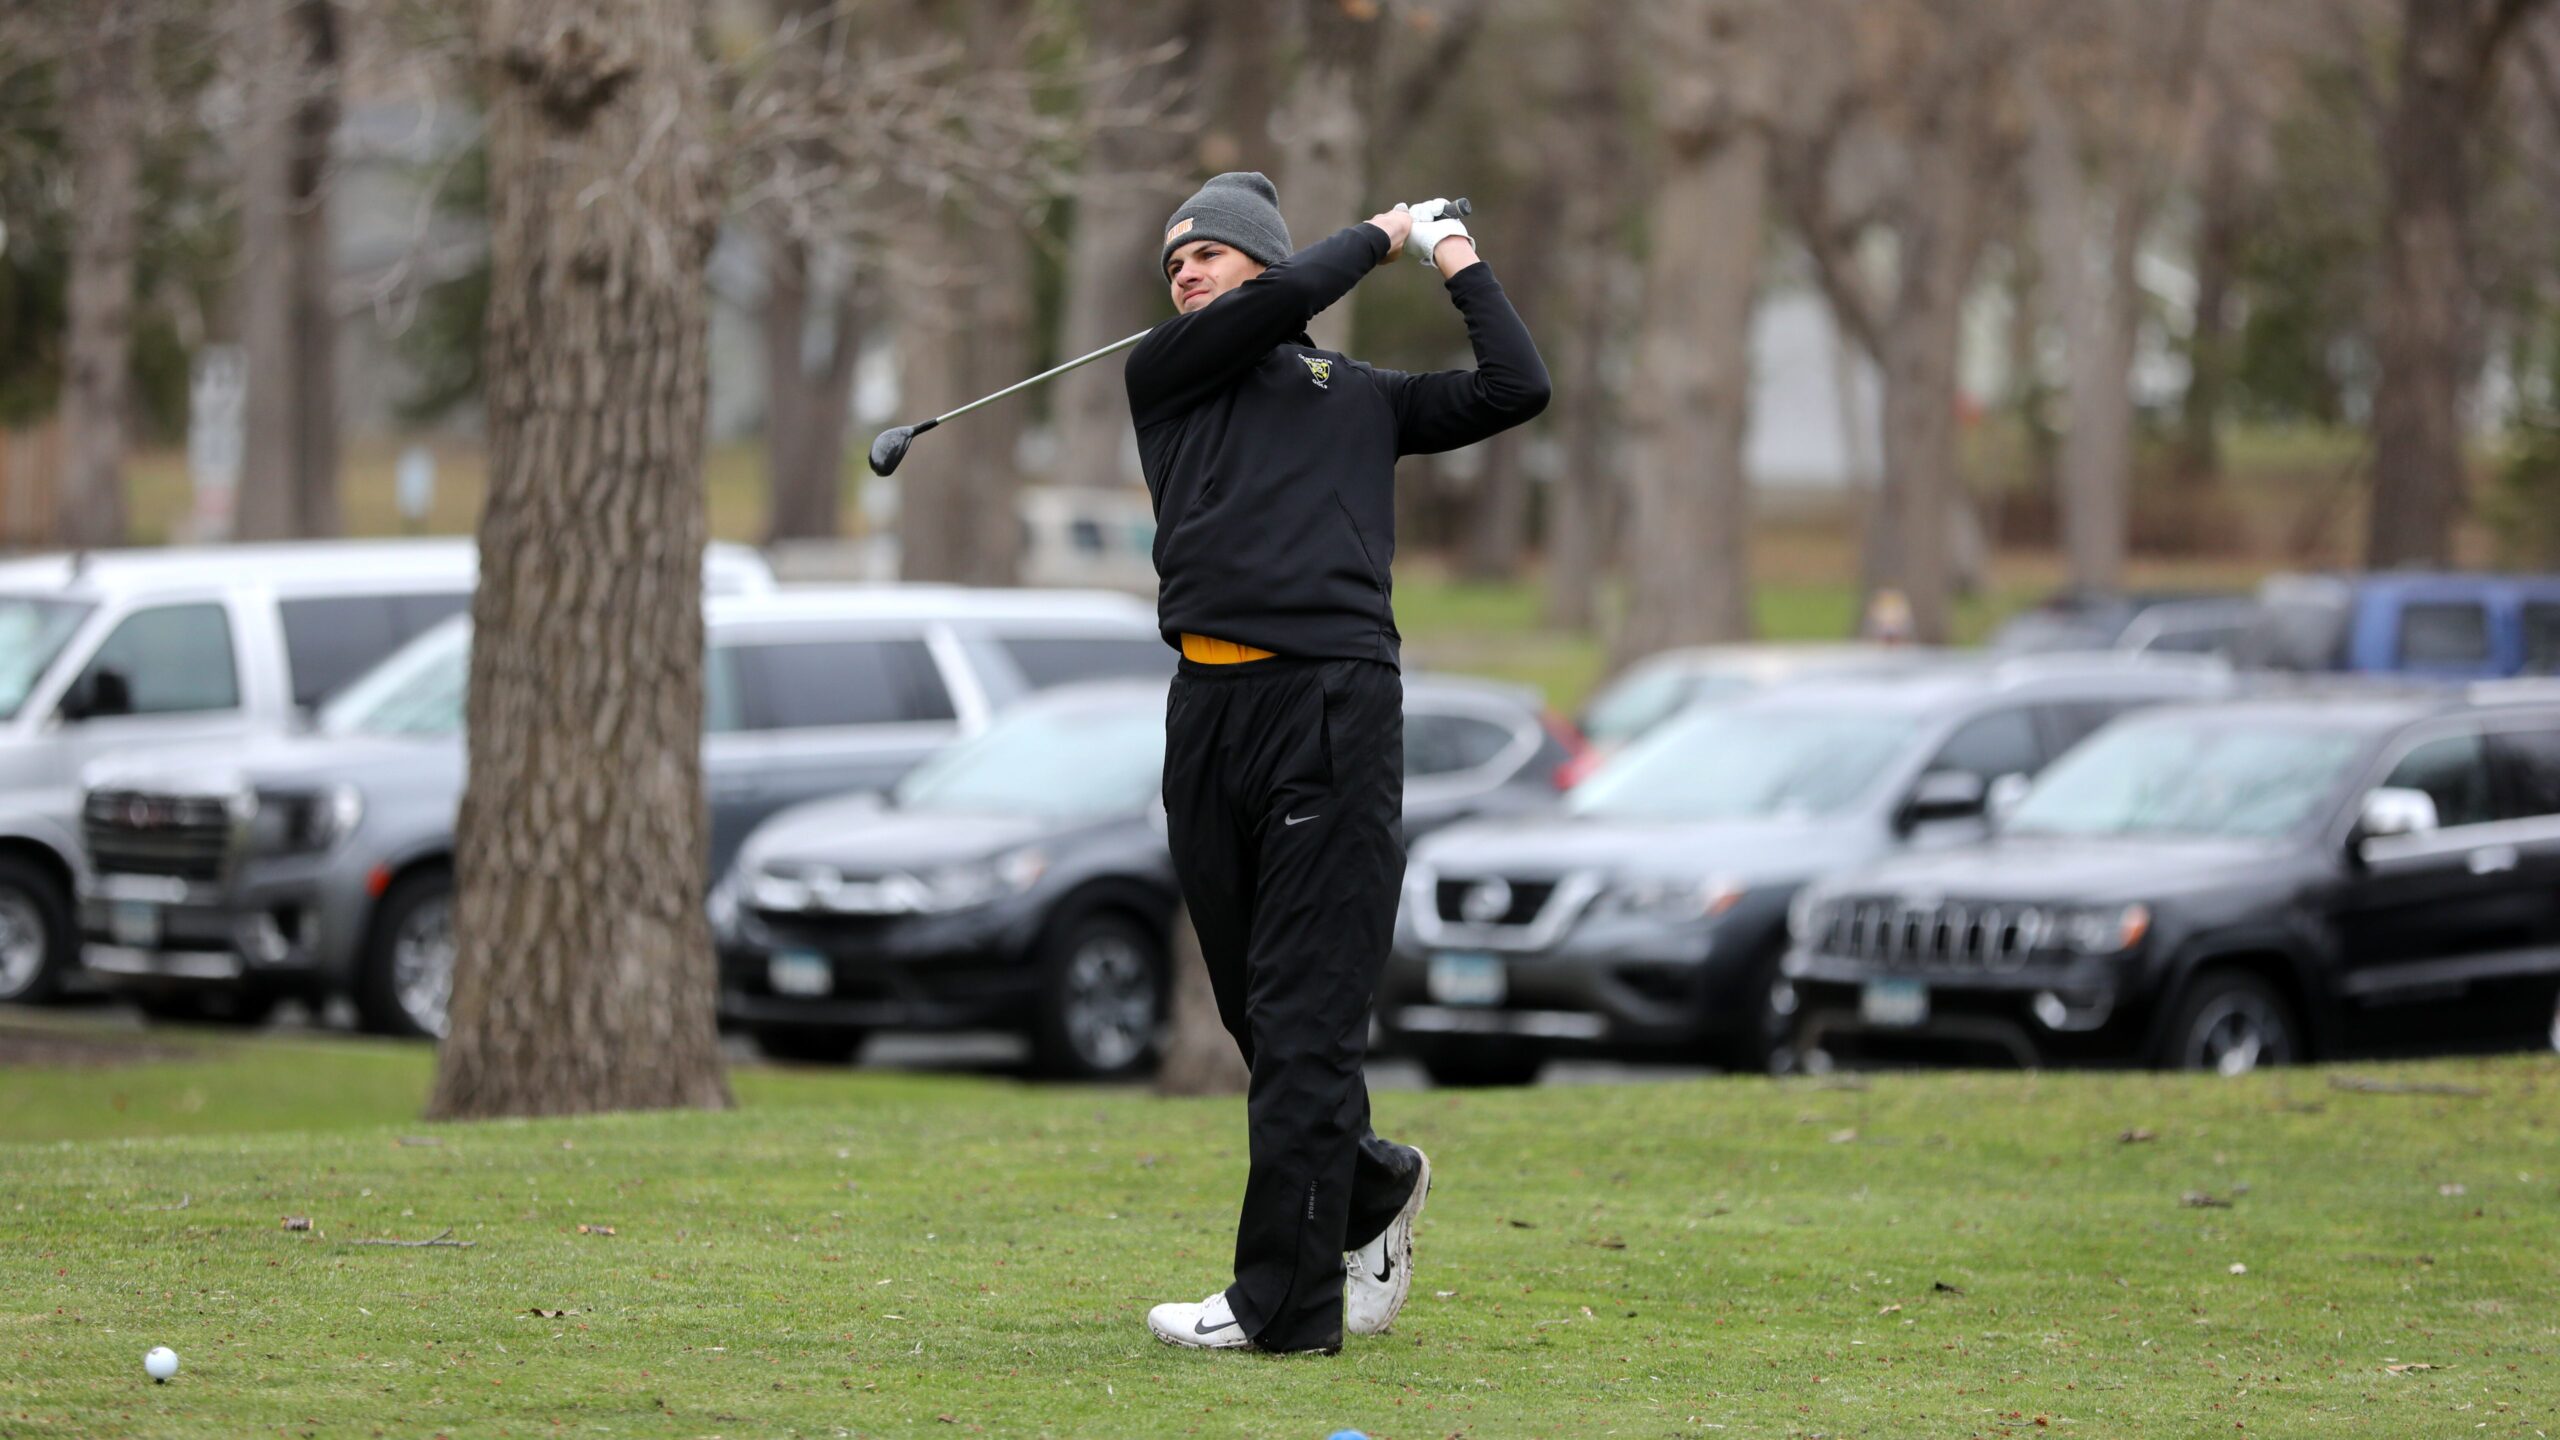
<box><xmin>1784</xmin><ymin>687</ymin><xmax>2560</xmax><ymax>1074</ymax></box>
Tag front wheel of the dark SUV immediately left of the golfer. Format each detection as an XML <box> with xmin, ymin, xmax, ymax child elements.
<box><xmin>1032</xmin><ymin>910</ymin><xmax>1170</xmax><ymax>1079</ymax></box>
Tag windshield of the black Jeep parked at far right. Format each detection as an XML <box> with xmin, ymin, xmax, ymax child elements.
<box><xmin>2002</xmin><ymin>717</ymin><xmax>2363</xmax><ymax>838</ymax></box>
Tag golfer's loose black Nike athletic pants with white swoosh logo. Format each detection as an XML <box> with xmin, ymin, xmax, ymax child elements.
<box><xmin>1165</xmin><ymin>659</ymin><xmax>1421</xmax><ymax>1350</ymax></box>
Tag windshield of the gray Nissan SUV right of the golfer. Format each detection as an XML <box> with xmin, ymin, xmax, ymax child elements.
<box><xmin>1564</xmin><ymin>705</ymin><xmax>1917</xmax><ymax>820</ymax></box>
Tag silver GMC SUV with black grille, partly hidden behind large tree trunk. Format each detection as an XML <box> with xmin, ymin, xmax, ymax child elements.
<box><xmin>82</xmin><ymin>587</ymin><xmax>1172</xmax><ymax>1035</ymax></box>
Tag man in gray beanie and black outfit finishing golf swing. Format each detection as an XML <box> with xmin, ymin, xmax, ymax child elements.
<box><xmin>1126</xmin><ymin>172</ymin><xmax>1546</xmax><ymax>1353</ymax></box>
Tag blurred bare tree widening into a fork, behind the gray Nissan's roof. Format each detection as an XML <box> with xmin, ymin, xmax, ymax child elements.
<box><xmin>1779</xmin><ymin>0</ymin><xmax>2043</xmax><ymax>641</ymax></box>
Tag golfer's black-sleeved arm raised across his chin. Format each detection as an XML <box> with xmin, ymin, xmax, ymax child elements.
<box><xmin>1124</xmin><ymin>220</ymin><xmax>1411</xmax><ymax>430</ymax></box>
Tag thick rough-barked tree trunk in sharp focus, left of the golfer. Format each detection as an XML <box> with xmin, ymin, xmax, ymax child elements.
<box><xmin>430</xmin><ymin>0</ymin><xmax>730</xmax><ymax>1117</ymax></box>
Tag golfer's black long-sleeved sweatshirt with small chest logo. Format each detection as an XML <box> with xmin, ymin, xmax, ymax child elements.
<box><xmin>1126</xmin><ymin>223</ymin><xmax>1546</xmax><ymax>666</ymax></box>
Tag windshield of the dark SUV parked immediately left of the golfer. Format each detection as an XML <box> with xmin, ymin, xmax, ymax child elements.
<box><xmin>896</xmin><ymin>700</ymin><xmax>1165</xmax><ymax>820</ymax></box>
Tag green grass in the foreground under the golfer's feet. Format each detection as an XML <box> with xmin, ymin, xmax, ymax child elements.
<box><xmin>0</xmin><ymin>1014</ymin><xmax>2560</xmax><ymax>1440</ymax></box>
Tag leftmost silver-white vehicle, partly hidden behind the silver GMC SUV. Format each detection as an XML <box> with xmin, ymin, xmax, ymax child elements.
<box><xmin>0</xmin><ymin>538</ymin><xmax>773</xmax><ymax>1002</ymax></box>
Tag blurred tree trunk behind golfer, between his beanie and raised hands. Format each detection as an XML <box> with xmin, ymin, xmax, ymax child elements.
<box><xmin>1272</xmin><ymin>0</ymin><xmax>1385</xmax><ymax>351</ymax></box>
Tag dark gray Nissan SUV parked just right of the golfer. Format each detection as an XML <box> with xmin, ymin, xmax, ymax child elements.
<box><xmin>1377</xmin><ymin>656</ymin><xmax>2230</xmax><ymax>1084</ymax></box>
